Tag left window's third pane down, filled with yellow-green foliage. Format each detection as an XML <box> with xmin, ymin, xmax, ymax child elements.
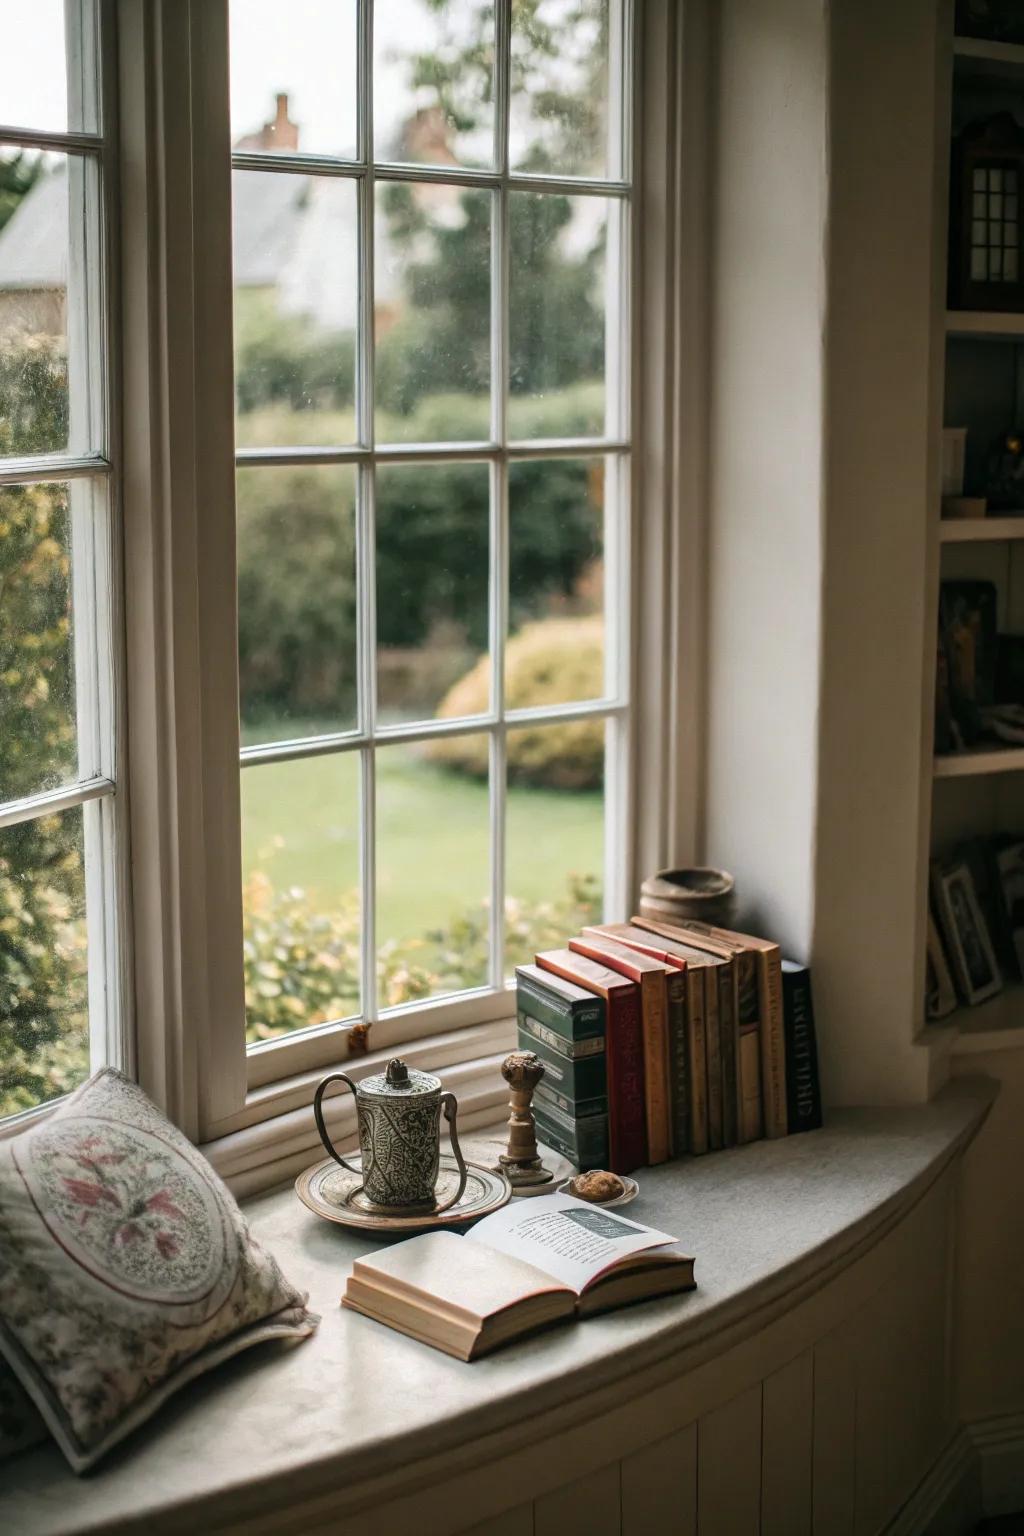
<box><xmin>0</xmin><ymin>485</ymin><xmax>78</xmax><ymax>800</ymax></box>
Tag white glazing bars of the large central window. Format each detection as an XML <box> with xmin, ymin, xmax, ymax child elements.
<box><xmin>232</xmin><ymin>0</ymin><xmax>634</xmax><ymax>1086</ymax></box>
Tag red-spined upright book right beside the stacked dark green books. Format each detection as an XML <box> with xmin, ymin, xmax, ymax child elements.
<box><xmin>534</xmin><ymin>949</ymin><xmax>646</xmax><ymax>1174</ymax></box>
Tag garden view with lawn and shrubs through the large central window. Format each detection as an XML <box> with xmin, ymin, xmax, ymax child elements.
<box><xmin>230</xmin><ymin>0</ymin><xmax>629</xmax><ymax>1043</ymax></box>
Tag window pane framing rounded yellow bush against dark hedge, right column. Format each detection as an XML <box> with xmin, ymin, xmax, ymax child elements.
<box><xmin>505</xmin><ymin>458</ymin><xmax>605</xmax><ymax>710</ymax></box>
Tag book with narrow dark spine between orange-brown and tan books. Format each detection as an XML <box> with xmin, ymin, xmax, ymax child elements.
<box><xmin>583</xmin><ymin>923</ymin><xmax>708</xmax><ymax>1157</ymax></box>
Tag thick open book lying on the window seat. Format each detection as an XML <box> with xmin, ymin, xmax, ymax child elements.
<box><xmin>341</xmin><ymin>1195</ymin><xmax>694</xmax><ymax>1359</ymax></box>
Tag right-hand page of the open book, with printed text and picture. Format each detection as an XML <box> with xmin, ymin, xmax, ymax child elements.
<box><xmin>464</xmin><ymin>1195</ymin><xmax>676</xmax><ymax>1295</ymax></box>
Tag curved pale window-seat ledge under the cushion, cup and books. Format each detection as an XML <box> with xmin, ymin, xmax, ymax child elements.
<box><xmin>0</xmin><ymin>1078</ymin><xmax>995</xmax><ymax>1536</ymax></box>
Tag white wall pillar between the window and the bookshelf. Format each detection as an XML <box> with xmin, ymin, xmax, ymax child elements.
<box><xmin>705</xmin><ymin>0</ymin><xmax>938</xmax><ymax>1103</ymax></box>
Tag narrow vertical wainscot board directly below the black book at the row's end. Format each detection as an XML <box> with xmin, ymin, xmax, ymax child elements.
<box><xmin>761</xmin><ymin>1350</ymin><xmax>814</xmax><ymax>1536</ymax></box>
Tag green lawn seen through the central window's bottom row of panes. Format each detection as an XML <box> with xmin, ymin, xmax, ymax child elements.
<box><xmin>243</xmin><ymin>746</ymin><xmax>602</xmax><ymax>940</ymax></box>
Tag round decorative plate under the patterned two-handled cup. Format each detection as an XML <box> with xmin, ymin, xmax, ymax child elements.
<box><xmin>295</xmin><ymin>1154</ymin><xmax>511</xmax><ymax>1232</ymax></box>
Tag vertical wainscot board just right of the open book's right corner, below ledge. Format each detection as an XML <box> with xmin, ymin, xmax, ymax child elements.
<box><xmin>697</xmin><ymin>1382</ymin><xmax>761</xmax><ymax>1536</ymax></box>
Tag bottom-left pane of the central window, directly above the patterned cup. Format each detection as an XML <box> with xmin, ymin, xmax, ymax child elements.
<box><xmin>241</xmin><ymin>753</ymin><xmax>359</xmax><ymax>1043</ymax></box>
